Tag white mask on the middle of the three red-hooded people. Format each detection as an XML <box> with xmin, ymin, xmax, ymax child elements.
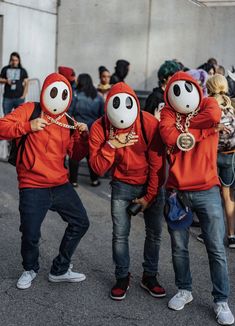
<box><xmin>107</xmin><ymin>93</ymin><xmax>138</xmax><ymax>129</ymax></box>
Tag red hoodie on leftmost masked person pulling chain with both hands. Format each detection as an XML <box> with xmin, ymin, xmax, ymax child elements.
<box><xmin>0</xmin><ymin>73</ymin><xmax>88</xmax><ymax>188</ymax></box>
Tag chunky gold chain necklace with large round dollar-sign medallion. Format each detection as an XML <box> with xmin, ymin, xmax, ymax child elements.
<box><xmin>176</xmin><ymin>108</ymin><xmax>200</xmax><ymax>152</ymax></box>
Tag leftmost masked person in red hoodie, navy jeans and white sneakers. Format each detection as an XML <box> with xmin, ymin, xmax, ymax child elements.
<box><xmin>0</xmin><ymin>73</ymin><xmax>89</xmax><ymax>289</ymax></box>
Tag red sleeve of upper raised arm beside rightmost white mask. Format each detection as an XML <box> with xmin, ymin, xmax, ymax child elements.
<box><xmin>190</xmin><ymin>97</ymin><xmax>221</xmax><ymax>129</ymax></box>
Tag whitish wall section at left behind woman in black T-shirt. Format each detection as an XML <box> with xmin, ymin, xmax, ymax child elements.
<box><xmin>0</xmin><ymin>0</ymin><xmax>57</xmax><ymax>86</ymax></box>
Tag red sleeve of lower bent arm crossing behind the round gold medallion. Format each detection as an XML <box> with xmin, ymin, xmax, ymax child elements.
<box><xmin>160</xmin><ymin>107</ymin><xmax>216</xmax><ymax>148</ymax></box>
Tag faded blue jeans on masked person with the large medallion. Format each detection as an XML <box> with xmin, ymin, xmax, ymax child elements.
<box><xmin>168</xmin><ymin>187</ymin><xmax>229</xmax><ymax>302</ymax></box>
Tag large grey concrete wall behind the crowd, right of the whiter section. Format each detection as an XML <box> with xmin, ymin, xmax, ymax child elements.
<box><xmin>57</xmin><ymin>0</ymin><xmax>235</xmax><ymax>90</ymax></box>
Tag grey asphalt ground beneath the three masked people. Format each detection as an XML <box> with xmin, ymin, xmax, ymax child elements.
<box><xmin>0</xmin><ymin>163</ymin><xmax>235</xmax><ymax>326</ymax></box>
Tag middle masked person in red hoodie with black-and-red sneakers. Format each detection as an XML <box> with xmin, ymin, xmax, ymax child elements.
<box><xmin>89</xmin><ymin>82</ymin><xmax>165</xmax><ymax>300</ymax></box>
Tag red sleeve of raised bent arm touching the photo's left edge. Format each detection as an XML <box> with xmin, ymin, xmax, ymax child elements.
<box><xmin>0</xmin><ymin>103</ymin><xmax>34</xmax><ymax>140</ymax></box>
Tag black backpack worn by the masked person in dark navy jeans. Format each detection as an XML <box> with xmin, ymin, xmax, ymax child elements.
<box><xmin>8</xmin><ymin>102</ymin><xmax>74</xmax><ymax>166</ymax></box>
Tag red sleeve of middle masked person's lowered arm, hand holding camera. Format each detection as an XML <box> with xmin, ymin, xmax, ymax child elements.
<box><xmin>143</xmin><ymin>113</ymin><xmax>165</xmax><ymax>202</ymax></box>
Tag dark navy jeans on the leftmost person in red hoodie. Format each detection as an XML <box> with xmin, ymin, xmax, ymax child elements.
<box><xmin>19</xmin><ymin>183</ymin><xmax>89</xmax><ymax>275</ymax></box>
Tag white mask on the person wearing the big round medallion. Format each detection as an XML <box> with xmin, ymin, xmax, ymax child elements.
<box><xmin>167</xmin><ymin>80</ymin><xmax>200</xmax><ymax>114</ymax></box>
